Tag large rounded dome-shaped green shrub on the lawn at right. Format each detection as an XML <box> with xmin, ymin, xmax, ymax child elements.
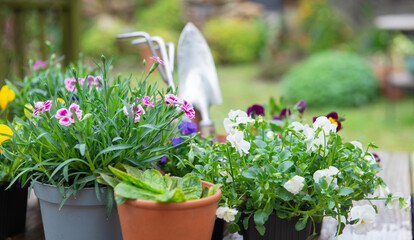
<box><xmin>282</xmin><ymin>51</ymin><xmax>378</xmax><ymax>107</ymax></box>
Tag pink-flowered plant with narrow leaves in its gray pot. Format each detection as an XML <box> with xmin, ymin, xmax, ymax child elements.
<box><xmin>1</xmin><ymin>57</ymin><xmax>194</xmax><ymax>239</ymax></box>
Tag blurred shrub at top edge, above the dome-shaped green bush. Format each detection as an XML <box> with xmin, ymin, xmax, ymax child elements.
<box><xmin>297</xmin><ymin>0</ymin><xmax>352</xmax><ymax>53</ymax></box>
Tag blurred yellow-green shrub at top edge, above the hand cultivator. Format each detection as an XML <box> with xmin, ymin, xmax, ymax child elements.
<box><xmin>135</xmin><ymin>0</ymin><xmax>184</xmax><ymax>32</ymax></box>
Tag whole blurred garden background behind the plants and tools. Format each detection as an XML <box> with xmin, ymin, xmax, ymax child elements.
<box><xmin>0</xmin><ymin>0</ymin><xmax>414</xmax><ymax>151</ymax></box>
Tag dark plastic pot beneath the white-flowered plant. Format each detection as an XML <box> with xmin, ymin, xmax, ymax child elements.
<box><xmin>243</xmin><ymin>213</ymin><xmax>311</xmax><ymax>240</ymax></box>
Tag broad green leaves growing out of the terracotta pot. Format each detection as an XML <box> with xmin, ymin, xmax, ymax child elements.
<box><xmin>101</xmin><ymin>165</ymin><xmax>218</xmax><ymax>204</ymax></box>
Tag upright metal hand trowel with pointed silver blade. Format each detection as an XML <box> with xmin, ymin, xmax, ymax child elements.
<box><xmin>177</xmin><ymin>22</ymin><xmax>223</xmax><ymax>137</ymax></box>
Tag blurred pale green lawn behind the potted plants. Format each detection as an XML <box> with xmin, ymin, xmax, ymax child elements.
<box><xmin>118</xmin><ymin>64</ymin><xmax>414</xmax><ymax>152</ymax></box>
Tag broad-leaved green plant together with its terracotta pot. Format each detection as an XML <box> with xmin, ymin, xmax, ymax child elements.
<box><xmin>101</xmin><ymin>165</ymin><xmax>221</xmax><ymax>240</ymax></box>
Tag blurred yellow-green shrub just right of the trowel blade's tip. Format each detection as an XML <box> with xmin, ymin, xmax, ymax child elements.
<box><xmin>203</xmin><ymin>18</ymin><xmax>266</xmax><ymax>63</ymax></box>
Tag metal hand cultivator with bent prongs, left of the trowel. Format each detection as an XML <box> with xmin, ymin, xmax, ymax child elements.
<box><xmin>117</xmin><ymin>31</ymin><xmax>175</xmax><ymax>90</ymax></box>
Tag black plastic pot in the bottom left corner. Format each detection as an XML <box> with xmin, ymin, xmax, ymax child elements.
<box><xmin>0</xmin><ymin>182</ymin><xmax>27</xmax><ymax>240</ymax></box>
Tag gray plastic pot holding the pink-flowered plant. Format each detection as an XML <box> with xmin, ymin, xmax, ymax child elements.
<box><xmin>34</xmin><ymin>182</ymin><xmax>122</xmax><ymax>240</ymax></box>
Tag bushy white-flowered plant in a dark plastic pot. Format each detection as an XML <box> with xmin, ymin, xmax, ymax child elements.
<box><xmin>188</xmin><ymin>103</ymin><xmax>410</xmax><ymax>239</ymax></box>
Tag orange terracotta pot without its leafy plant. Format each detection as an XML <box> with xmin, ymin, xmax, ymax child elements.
<box><xmin>118</xmin><ymin>181</ymin><xmax>221</xmax><ymax>240</ymax></box>
